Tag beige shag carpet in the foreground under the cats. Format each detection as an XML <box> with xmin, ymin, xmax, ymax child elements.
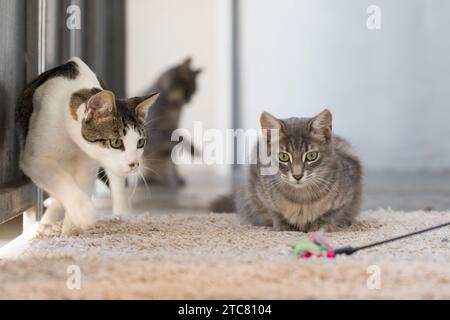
<box><xmin>0</xmin><ymin>210</ymin><xmax>450</xmax><ymax>299</ymax></box>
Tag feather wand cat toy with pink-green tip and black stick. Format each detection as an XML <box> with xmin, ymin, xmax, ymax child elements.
<box><xmin>292</xmin><ymin>222</ymin><xmax>450</xmax><ymax>258</ymax></box>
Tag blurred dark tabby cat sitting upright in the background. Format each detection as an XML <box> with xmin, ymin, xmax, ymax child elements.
<box><xmin>142</xmin><ymin>58</ymin><xmax>201</xmax><ymax>188</ymax></box>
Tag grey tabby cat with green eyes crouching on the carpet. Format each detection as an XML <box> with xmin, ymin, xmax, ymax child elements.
<box><xmin>212</xmin><ymin>110</ymin><xmax>362</xmax><ymax>232</ymax></box>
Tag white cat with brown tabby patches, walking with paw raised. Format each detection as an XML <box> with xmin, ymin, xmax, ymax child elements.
<box><xmin>16</xmin><ymin>58</ymin><xmax>158</xmax><ymax>234</ymax></box>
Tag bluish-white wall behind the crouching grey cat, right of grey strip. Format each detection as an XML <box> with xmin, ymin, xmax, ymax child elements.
<box><xmin>241</xmin><ymin>0</ymin><xmax>450</xmax><ymax>170</ymax></box>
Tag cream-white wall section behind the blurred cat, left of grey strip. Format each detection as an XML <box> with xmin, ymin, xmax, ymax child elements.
<box><xmin>126</xmin><ymin>0</ymin><xmax>231</xmax><ymax>165</ymax></box>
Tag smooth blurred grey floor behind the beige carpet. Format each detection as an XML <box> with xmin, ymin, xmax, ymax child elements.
<box><xmin>95</xmin><ymin>170</ymin><xmax>450</xmax><ymax>211</ymax></box>
